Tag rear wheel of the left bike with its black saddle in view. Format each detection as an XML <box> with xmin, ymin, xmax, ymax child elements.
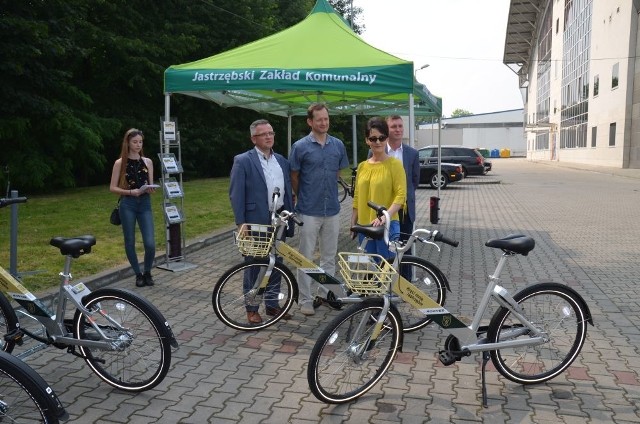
<box><xmin>73</xmin><ymin>289</ymin><xmax>173</xmax><ymax>392</ymax></box>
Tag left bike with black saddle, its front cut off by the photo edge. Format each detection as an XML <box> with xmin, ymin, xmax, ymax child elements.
<box><xmin>0</xmin><ymin>198</ymin><xmax>178</xmax><ymax>392</ymax></box>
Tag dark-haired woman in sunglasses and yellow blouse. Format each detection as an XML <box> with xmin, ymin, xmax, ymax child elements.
<box><xmin>351</xmin><ymin>117</ymin><xmax>407</xmax><ymax>258</ymax></box>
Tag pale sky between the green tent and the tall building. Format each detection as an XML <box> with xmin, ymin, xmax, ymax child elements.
<box><xmin>353</xmin><ymin>0</ymin><xmax>523</xmax><ymax>117</ymax></box>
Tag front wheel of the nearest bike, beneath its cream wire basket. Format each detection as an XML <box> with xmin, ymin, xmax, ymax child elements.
<box><xmin>307</xmin><ymin>298</ymin><xmax>402</xmax><ymax>403</ymax></box>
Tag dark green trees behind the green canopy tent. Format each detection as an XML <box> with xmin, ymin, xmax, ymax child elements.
<box><xmin>0</xmin><ymin>0</ymin><xmax>361</xmax><ymax>192</ymax></box>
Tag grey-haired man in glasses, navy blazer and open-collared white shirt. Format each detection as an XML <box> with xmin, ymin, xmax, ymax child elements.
<box><xmin>229</xmin><ymin>119</ymin><xmax>293</xmax><ymax>324</ymax></box>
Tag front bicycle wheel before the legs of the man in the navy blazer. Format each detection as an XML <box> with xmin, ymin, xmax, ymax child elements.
<box><xmin>211</xmin><ymin>259</ymin><xmax>298</xmax><ymax>331</ymax></box>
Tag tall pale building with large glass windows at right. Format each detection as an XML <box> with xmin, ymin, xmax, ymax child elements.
<box><xmin>504</xmin><ymin>0</ymin><xmax>640</xmax><ymax>168</ymax></box>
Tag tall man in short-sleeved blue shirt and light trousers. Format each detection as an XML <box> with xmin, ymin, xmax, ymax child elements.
<box><xmin>289</xmin><ymin>103</ymin><xmax>349</xmax><ymax>315</ymax></box>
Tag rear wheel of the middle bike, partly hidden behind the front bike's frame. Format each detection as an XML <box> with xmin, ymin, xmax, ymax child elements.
<box><xmin>395</xmin><ymin>255</ymin><xmax>449</xmax><ymax>333</ymax></box>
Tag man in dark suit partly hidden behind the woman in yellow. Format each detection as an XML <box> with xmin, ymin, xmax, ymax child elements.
<box><xmin>387</xmin><ymin>115</ymin><xmax>420</xmax><ymax>278</ymax></box>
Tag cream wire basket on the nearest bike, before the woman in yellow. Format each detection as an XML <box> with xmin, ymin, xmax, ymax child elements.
<box><xmin>338</xmin><ymin>252</ymin><xmax>396</xmax><ymax>296</ymax></box>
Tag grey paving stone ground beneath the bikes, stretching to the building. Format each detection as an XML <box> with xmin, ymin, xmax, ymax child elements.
<box><xmin>12</xmin><ymin>158</ymin><xmax>640</xmax><ymax>424</ymax></box>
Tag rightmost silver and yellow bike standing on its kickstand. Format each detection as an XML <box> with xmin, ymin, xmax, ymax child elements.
<box><xmin>307</xmin><ymin>204</ymin><xmax>593</xmax><ymax>407</ymax></box>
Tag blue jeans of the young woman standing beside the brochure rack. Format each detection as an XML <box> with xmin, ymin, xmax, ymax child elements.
<box><xmin>120</xmin><ymin>194</ymin><xmax>156</xmax><ymax>275</ymax></box>
